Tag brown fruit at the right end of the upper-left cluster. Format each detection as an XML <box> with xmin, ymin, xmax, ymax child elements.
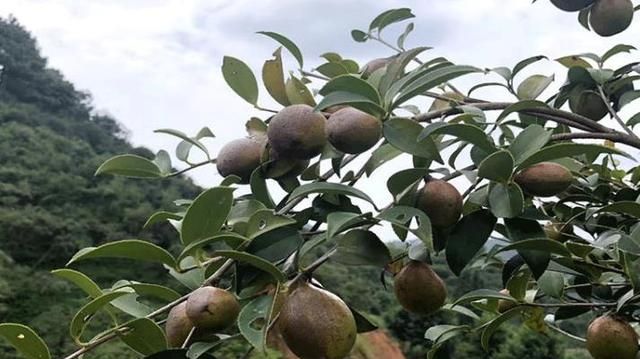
<box><xmin>327</xmin><ymin>107</ymin><xmax>382</xmax><ymax>154</ymax></box>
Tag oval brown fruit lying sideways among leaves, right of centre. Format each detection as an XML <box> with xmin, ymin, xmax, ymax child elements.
<box><xmin>514</xmin><ymin>162</ymin><xmax>573</xmax><ymax>197</ymax></box>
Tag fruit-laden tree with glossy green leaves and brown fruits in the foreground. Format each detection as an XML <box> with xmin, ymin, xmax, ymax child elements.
<box><xmin>0</xmin><ymin>0</ymin><xmax>640</xmax><ymax>359</ymax></box>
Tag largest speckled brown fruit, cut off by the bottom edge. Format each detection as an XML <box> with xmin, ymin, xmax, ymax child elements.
<box><xmin>278</xmin><ymin>283</ymin><xmax>357</xmax><ymax>359</ymax></box>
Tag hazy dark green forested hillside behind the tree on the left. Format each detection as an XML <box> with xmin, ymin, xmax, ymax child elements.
<box><xmin>0</xmin><ymin>18</ymin><xmax>199</xmax><ymax>358</ymax></box>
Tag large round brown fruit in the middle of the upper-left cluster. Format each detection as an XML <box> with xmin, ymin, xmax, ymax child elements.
<box><xmin>267</xmin><ymin>105</ymin><xmax>327</xmax><ymax>160</ymax></box>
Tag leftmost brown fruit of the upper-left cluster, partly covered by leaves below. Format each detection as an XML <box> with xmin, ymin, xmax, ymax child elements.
<box><xmin>216</xmin><ymin>138</ymin><xmax>262</xmax><ymax>183</ymax></box>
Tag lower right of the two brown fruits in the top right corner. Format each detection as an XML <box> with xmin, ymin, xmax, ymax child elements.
<box><xmin>589</xmin><ymin>0</ymin><xmax>633</xmax><ymax>36</ymax></box>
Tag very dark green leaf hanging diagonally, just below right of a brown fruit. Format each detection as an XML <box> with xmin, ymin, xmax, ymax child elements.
<box><xmin>445</xmin><ymin>209</ymin><xmax>497</xmax><ymax>276</ymax></box>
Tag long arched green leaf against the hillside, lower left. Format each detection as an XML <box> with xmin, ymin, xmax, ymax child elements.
<box><xmin>67</xmin><ymin>239</ymin><xmax>176</xmax><ymax>267</ymax></box>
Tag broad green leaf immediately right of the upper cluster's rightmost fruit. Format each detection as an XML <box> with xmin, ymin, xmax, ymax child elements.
<box><xmin>383</xmin><ymin>118</ymin><xmax>442</xmax><ymax>163</ymax></box>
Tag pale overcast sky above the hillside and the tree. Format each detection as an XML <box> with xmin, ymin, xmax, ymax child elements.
<box><xmin>0</xmin><ymin>0</ymin><xmax>640</xmax><ymax>194</ymax></box>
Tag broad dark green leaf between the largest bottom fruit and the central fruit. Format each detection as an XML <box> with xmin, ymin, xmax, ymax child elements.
<box><xmin>331</xmin><ymin>229</ymin><xmax>391</xmax><ymax>267</ymax></box>
